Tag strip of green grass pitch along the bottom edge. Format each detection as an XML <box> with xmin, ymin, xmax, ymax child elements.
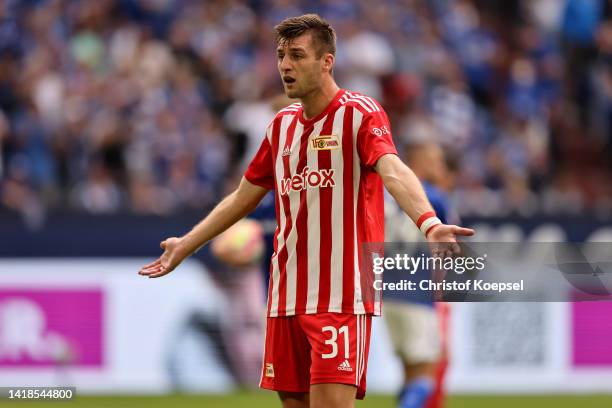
<box><xmin>0</xmin><ymin>392</ymin><xmax>612</xmax><ymax>408</ymax></box>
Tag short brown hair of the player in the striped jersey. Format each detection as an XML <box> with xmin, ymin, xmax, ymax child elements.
<box><xmin>274</xmin><ymin>14</ymin><xmax>336</xmax><ymax>58</ymax></box>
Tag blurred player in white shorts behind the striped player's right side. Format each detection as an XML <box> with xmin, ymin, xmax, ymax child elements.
<box><xmin>383</xmin><ymin>138</ymin><xmax>457</xmax><ymax>408</ymax></box>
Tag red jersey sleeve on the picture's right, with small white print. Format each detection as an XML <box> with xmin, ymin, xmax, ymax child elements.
<box><xmin>357</xmin><ymin>111</ymin><xmax>397</xmax><ymax>167</ymax></box>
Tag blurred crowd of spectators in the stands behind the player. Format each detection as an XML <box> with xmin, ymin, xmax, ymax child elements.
<box><xmin>0</xmin><ymin>0</ymin><xmax>612</xmax><ymax>221</ymax></box>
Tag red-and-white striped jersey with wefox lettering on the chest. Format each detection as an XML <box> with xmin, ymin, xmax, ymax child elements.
<box><xmin>245</xmin><ymin>90</ymin><xmax>397</xmax><ymax>317</ymax></box>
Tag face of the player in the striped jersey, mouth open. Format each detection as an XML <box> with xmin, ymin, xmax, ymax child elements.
<box><xmin>276</xmin><ymin>33</ymin><xmax>329</xmax><ymax>99</ymax></box>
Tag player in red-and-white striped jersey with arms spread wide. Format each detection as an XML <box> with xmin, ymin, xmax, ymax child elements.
<box><xmin>139</xmin><ymin>14</ymin><xmax>473</xmax><ymax>408</ymax></box>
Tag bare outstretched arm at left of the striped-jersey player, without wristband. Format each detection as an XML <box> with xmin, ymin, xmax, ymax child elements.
<box><xmin>138</xmin><ymin>177</ymin><xmax>268</xmax><ymax>278</ymax></box>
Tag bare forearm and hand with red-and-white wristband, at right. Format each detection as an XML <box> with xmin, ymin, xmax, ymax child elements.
<box><xmin>374</xmin><ymin>153</ymin><xmax>474</xmax><ymax>252</ymax></box>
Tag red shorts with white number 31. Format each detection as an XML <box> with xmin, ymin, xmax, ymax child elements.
<box><xmin>259</xmin><ymin>313</ymin><xmax>372</xmax><ymax>399</ymax></box>
